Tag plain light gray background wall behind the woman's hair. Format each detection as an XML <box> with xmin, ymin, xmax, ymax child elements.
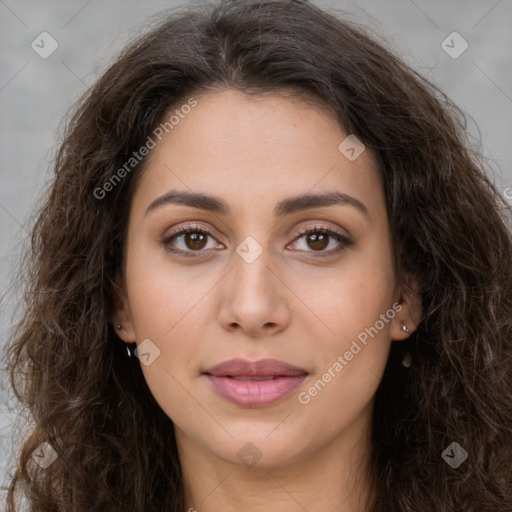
<box><xmin>0</xmin><ymin>0</ymin><xmax>512</xmax><ymax>504</ymax></box>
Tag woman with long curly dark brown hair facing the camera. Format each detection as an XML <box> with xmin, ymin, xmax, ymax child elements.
<box><xmin>2</xmin><ymin>0</ymin><xmax>512</xmax><ymax>512</ymax></box>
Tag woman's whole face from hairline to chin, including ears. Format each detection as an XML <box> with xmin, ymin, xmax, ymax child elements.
<box><xmin>114</xmin><ymin>90</ymin><xmax>416</xmax><ymax>467</ymax></box>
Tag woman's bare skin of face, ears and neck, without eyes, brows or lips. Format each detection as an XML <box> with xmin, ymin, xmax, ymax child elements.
<box><xmin>113</xmin><ymin>90</ymin><xmax>420</xmax><ymax>512</ymax></box>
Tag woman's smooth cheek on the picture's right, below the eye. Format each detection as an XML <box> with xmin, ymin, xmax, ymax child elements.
<box><xmin>296</xmin><ymin>240</ymin><xmax>396</xmax><ymax>400</ymax></box>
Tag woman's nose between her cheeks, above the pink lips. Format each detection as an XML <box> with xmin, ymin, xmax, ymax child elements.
<box><xmin>218</xmin><ymin>242</ymin><xmax>291</xmax><ymax>338</ymax></box>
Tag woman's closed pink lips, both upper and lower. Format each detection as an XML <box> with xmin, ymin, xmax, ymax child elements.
<box><xmin>204</xmin><ymin>359</ymin><xmax>308</xmax><ymax>407</ymax></box>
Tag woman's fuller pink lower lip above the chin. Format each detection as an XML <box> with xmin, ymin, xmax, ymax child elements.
<box><xmin>206</xmin><ymin>375</ymin><xmax>307</xmax><ymax>407</ymax></box>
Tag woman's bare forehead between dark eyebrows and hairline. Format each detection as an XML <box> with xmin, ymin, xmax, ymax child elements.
<box><xmin>130</xmin><ymin>90</ymin><xmax>382</xmax><ymax>220</ymax></box>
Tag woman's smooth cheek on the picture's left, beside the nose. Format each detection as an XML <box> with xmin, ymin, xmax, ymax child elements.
<box><xmin>126</xmin><ymin>259</ymin><xmax>208</xmax><ymax>426</ymax></box>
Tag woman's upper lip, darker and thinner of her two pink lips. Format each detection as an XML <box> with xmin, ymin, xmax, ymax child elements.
<box><xmin>204</xmin><ymin>358</ymin><xmax>308</xmax><ymax>377</ymax></box>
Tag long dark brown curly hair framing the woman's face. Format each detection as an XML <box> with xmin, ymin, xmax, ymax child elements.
<box><xmin>5</xmin><ymin>0</ymin><xmax>512</xmax><ymax>512</ymax></box>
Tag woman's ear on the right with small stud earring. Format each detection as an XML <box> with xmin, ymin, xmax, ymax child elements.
<box><xmin>391</xmin><ymin>274</ymin><xmax>423</xmax><ymax>340</ymax></box>
